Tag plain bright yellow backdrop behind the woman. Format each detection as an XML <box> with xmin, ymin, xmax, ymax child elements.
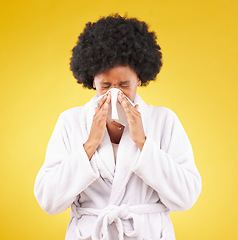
<box><xmin>0</xmin><ymin>0</ymin><xmax>238</xmax><ymax>240</ymax></box>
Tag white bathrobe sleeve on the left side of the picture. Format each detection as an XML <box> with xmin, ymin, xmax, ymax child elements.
<box><xmin>34</xmin><ymin>111</ymin><xmax>99</xmax><ymax>214</ymax></box>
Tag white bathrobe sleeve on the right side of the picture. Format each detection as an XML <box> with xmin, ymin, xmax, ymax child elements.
<box><xmin>133</xmin><ymin>110</ymin><xmax>202</xmax><ymax>211</ymax></box>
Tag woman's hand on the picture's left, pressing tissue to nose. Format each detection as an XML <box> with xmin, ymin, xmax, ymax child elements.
<box><xmin>83</xmin><ymin>92</ymin><xmax>111</xmax><ymax>160</ymax></box>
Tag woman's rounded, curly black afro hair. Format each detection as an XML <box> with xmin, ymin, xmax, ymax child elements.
<box><xmin>70</xmin><ymin>14</ymin><xmax>162</xmax><ymax>89</ymax></box>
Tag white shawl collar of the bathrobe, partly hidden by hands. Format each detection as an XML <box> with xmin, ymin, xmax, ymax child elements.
<box><xmin>82</xmin><ymin>94</ymin><xmax>148</xmax><ymax>205</ymax></box>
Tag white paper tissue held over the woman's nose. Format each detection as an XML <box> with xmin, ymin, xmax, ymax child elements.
<box><xmin>96</xmin><ymin>88</ymin><xmax>135</xmax><ymax>126</ymax></box>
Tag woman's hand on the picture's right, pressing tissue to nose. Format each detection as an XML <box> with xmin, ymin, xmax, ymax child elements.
<box><xmin>118</xmin><ymin>92</ymin><xmax>146</xmax><ymax>150</ymax></box>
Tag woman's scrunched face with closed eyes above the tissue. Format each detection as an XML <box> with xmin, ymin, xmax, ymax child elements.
<box><xmin>93</xmin><ymin>66</ymin><xmax>140</xmax><ymax>101</ymax></box>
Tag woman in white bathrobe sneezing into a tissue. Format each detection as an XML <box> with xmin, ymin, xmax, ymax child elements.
<box><xmin>34</xmin><ymin>15</ymin><xmax>201</xmax><ymax>240</ymax></box>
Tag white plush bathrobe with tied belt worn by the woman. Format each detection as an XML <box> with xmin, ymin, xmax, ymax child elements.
<box><xmin>34</xmin><ymin>95</ymin><xmax>201</xmax><ymax>240</ymax></box>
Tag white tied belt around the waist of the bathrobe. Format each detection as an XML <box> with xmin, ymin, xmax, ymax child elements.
<box><xmin>71</xmin><ymin>203</ymin><xmax>169</xmax><ymax>240</ymax></box>
